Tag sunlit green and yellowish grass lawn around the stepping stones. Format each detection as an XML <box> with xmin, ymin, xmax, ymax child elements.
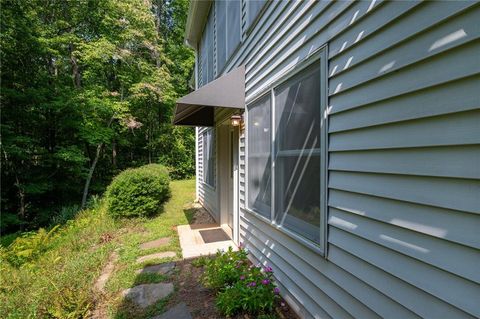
<box><xmin>0</xmin><ymin>180</ymin><xmax>195</xmax><ymax>318</ymax></box>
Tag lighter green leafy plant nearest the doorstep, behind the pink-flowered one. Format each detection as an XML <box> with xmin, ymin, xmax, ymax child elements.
<box><xmin>201</xmin><ymin>247</ymin><xmax>248</xmax><ymax>290</ymax></box>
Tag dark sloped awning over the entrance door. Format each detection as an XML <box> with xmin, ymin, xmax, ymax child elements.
<box><xmin>173</xmin><ymin>66</ymin><xmax>245</xmax><ymax>126</ymax></box>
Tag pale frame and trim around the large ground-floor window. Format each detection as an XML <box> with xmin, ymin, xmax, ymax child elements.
<box><xmin>245</xmin><ymin>45</ymin><xmax>328</xmax><ymax>258</ymax></box>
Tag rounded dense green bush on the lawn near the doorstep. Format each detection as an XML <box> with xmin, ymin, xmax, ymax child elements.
<box><xmin>106</xmin><ymin>164</ymin><xmax>170</xmax><ymax>217</ymax></box>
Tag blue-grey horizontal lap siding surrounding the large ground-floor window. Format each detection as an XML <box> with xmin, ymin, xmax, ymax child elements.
<box><xmin>195</xmin><ymin>1</ymin><xmax>480</xmax><ymax>318</ymax></box>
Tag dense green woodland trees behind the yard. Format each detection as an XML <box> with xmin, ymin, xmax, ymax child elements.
<box><xmin>0</xmin><ymin>0</ymin><xmax>194</xmax><ymax>231</ymax></box>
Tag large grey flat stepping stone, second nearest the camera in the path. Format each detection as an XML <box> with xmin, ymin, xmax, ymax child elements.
<box><xmin>122</xmin><ymin>283</ymin><xmax>174</xmax><ymax>308</ymax></box>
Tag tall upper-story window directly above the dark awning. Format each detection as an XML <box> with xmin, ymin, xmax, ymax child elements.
<box><xmin>215</xmin><ymin>0</ymin><xmax>242</xmax><ymax>74</ymax></box>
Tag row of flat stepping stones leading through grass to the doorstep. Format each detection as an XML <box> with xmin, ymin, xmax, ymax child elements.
<box><xmin>122</xmin><ymin>237</ymin><xmax>192</xmax><ymax>319</ymax></box>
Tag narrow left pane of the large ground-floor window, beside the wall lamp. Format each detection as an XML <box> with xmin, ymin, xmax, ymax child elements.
<box><xmin>247</xmin><ymin>95</ymin><xmax>271</xmax><ymax>219</ymax></box>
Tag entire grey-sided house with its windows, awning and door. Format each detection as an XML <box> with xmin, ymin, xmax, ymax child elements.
<box><xmin>174</xmin><ymin>0</ymin><xmax>480</xmax><ymax>319</ymax></box>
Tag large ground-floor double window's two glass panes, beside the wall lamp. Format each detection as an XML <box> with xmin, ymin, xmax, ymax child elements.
<box><xmin>247</xmin><ymin>58</ymin><xmax>325</xmax><ymax>250</ymax></box>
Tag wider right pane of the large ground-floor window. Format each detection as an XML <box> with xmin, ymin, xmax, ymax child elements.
<box><xmin>275</xmin><ymin>64</ymin><xmax>321</xmax><ymax>243</ymax></box>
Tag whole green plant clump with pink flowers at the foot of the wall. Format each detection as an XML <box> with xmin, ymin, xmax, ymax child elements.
<box><xmin>202</xmin><ymin>248</ymin><xmax>279</xmax><ymax>316</ymax></box>
